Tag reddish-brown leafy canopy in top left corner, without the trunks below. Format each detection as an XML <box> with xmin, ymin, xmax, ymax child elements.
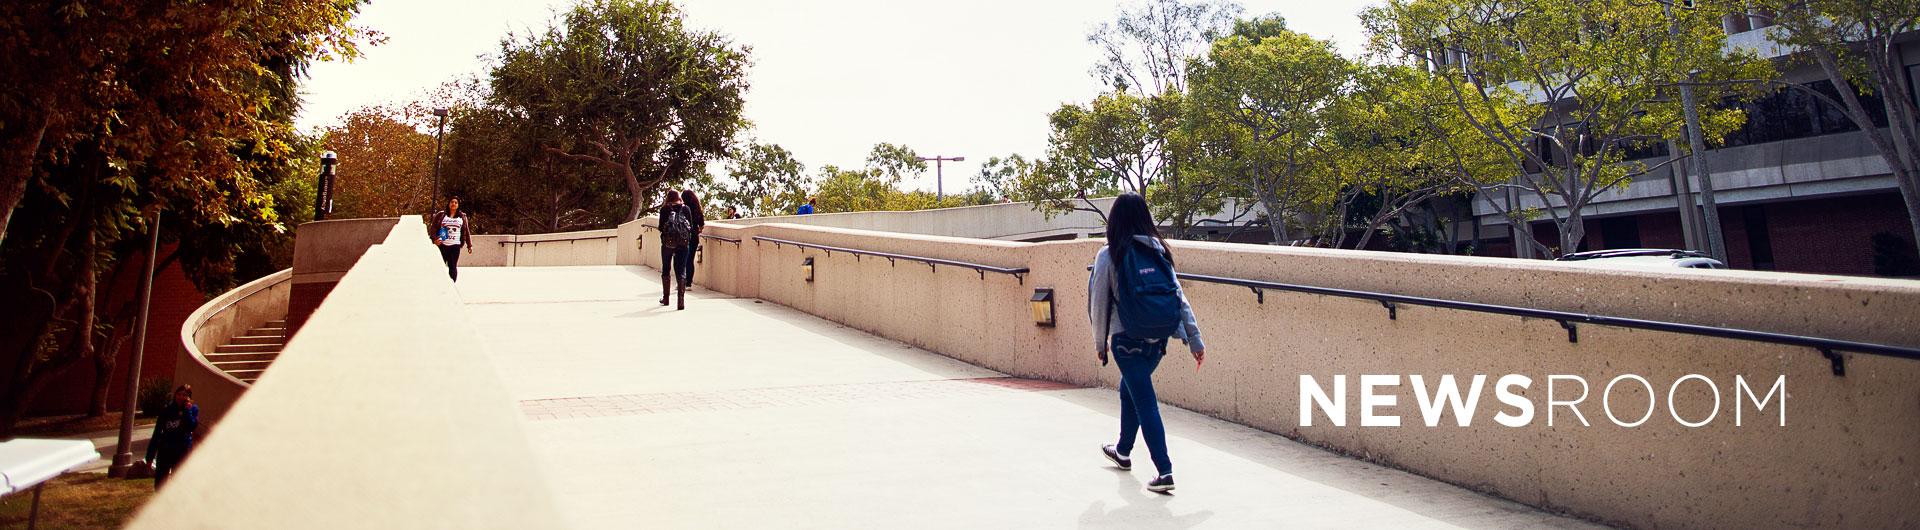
<box><xmin>0</xmin><ymin>0</ymin><xmax>378</xmax><ymax>255</ymax></box>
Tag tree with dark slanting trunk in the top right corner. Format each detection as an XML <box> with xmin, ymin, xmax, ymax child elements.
<box><xmin>1757</xmin><ymin>0</ymin><xmax>1920</xmax><ymax>259</ymax></box>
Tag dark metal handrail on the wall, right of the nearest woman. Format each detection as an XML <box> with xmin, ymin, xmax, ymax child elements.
<box><xmin>1128</xmin><ymin>267</ymin><xmax>1920</xmax><ymax>374</ymax></box>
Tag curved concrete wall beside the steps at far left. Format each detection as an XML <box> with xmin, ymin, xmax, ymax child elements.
<box><xmin>173</xmin><ymin>269</ymin><xmax>294</xmax><ymax>432</ymax></box>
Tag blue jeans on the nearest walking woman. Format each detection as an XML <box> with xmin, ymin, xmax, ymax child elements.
<box><xmin>1110</xmin><ymin>334</ymin><xmax>1173</xmax><ymax>474</ymax></box>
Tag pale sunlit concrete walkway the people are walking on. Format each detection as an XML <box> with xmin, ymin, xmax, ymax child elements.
<box><xmin>459</xmin><ymin>267</ymin><xmax>1590</xmax><ymax>528</ymax></box>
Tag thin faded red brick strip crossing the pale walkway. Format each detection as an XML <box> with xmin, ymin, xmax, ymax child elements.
<box><xmin>520</xmin><ymin>376</ymin><xmax>1079</xmax><ymax>421</ymax></box>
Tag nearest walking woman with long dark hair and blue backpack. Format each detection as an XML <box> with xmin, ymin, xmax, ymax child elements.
<box><xmin>1087</xmin><ymin>194</ymin><xmax>1206</xmax><ymax>494</ymax></box>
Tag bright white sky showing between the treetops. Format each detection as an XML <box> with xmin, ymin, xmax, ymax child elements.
<box><xmin>298</xmin><ymin>0</ymin><xmax>1371</xmax><ymax>192</ymax></box>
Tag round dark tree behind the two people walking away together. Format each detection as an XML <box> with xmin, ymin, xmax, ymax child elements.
<box><xmin>490</xmin><ymin>0</ymin><xmax>749</xmax><ymax>221</ymax></box>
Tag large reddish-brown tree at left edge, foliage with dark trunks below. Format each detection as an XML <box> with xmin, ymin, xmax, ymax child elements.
<box><xmin>0</xmin><ymin>0</ymin><xmax>365</xmax><ymax>438</ymax></box>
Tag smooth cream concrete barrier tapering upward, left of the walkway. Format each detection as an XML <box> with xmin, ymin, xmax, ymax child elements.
<box><xmin>131</xmin><ymin>215</ymin><xmax>563</xmax><ymax>528</ymax></box>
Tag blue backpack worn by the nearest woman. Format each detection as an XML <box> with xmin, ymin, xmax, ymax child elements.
<box><xmin>1114</xmin><ymin>242</ymin><xmax>1185</xmax><ymax>338</ymax></box>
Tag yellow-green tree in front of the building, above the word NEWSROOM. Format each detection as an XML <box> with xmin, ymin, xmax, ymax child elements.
<box><xmin>1361</xmin><ymin>0</ymin><xmax>1770</xmax><ymax>257</ymax></box>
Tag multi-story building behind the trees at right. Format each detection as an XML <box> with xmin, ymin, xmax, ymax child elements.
<box><xmin>1459</xmin><ymin>15</ymin><xmax>1920</xmax><ymax>275</ymax></box>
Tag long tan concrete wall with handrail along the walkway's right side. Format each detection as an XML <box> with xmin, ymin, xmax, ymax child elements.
<box><xmin>620</xmin><ymin>223</ymin><xmax>1920</xmax><ymax>528</ymax></box>
